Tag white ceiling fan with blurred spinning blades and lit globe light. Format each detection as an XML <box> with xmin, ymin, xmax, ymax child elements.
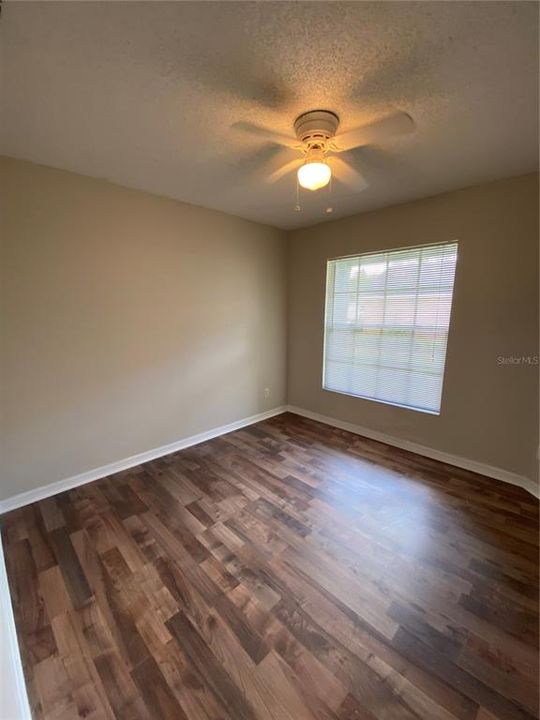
<box><xmin>234</xmin><ymin>110</ymin><xmax>414</xmax><ymax>192</ymax></box>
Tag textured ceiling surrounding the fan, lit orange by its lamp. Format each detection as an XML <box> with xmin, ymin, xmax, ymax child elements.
<box><xmin>0</xmin><ymin>1</ymin><xmax>538</xmax><ymax>228</ymax></box>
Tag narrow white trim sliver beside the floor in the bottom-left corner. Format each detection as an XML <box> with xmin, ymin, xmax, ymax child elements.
<box><xmin>0</xmin><ymin>542</ymin><xmax>32</xmax><ymax>720</ymax></box>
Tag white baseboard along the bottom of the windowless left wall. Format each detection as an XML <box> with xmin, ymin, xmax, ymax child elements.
<box><xmin>0</xmin><ymin>406</ymin><xmax>287</xmax><ymax>515</ymax></box>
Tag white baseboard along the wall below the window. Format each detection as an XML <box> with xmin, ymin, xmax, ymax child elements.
<box><xmin>287</xmin><ymin>405</ymin><xmax>539</xmax><ymax>497</ymax></box>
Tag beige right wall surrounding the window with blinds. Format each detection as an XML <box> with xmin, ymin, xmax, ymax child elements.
<box><xmin>288</xmin><ymin>175</ymin><xmax>538</xmax><ymax>479</ymax></box>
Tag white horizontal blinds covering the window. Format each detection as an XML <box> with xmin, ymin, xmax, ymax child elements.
<box><xmin>324</xmin><ymin>242</ymin><xmax>457</xmax><ymax>412</ymax></box>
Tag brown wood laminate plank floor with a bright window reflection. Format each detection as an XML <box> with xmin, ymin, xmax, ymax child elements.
<box><xmin>2</xmin><ymin>414</ymin><xmax>538</xmax><ymax>720</ymax></box>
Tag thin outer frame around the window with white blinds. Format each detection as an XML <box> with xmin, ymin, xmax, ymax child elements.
<box><xmin>321</xmin><ymin>238</ymin><xmax>460</xmax><ymax>417</ymax></box>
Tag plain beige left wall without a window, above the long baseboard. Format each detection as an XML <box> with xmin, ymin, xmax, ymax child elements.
<box><xmin>0</xmin><ymin>159</ymin><xmax>286</xmax><ymax>498</ymax></box>
